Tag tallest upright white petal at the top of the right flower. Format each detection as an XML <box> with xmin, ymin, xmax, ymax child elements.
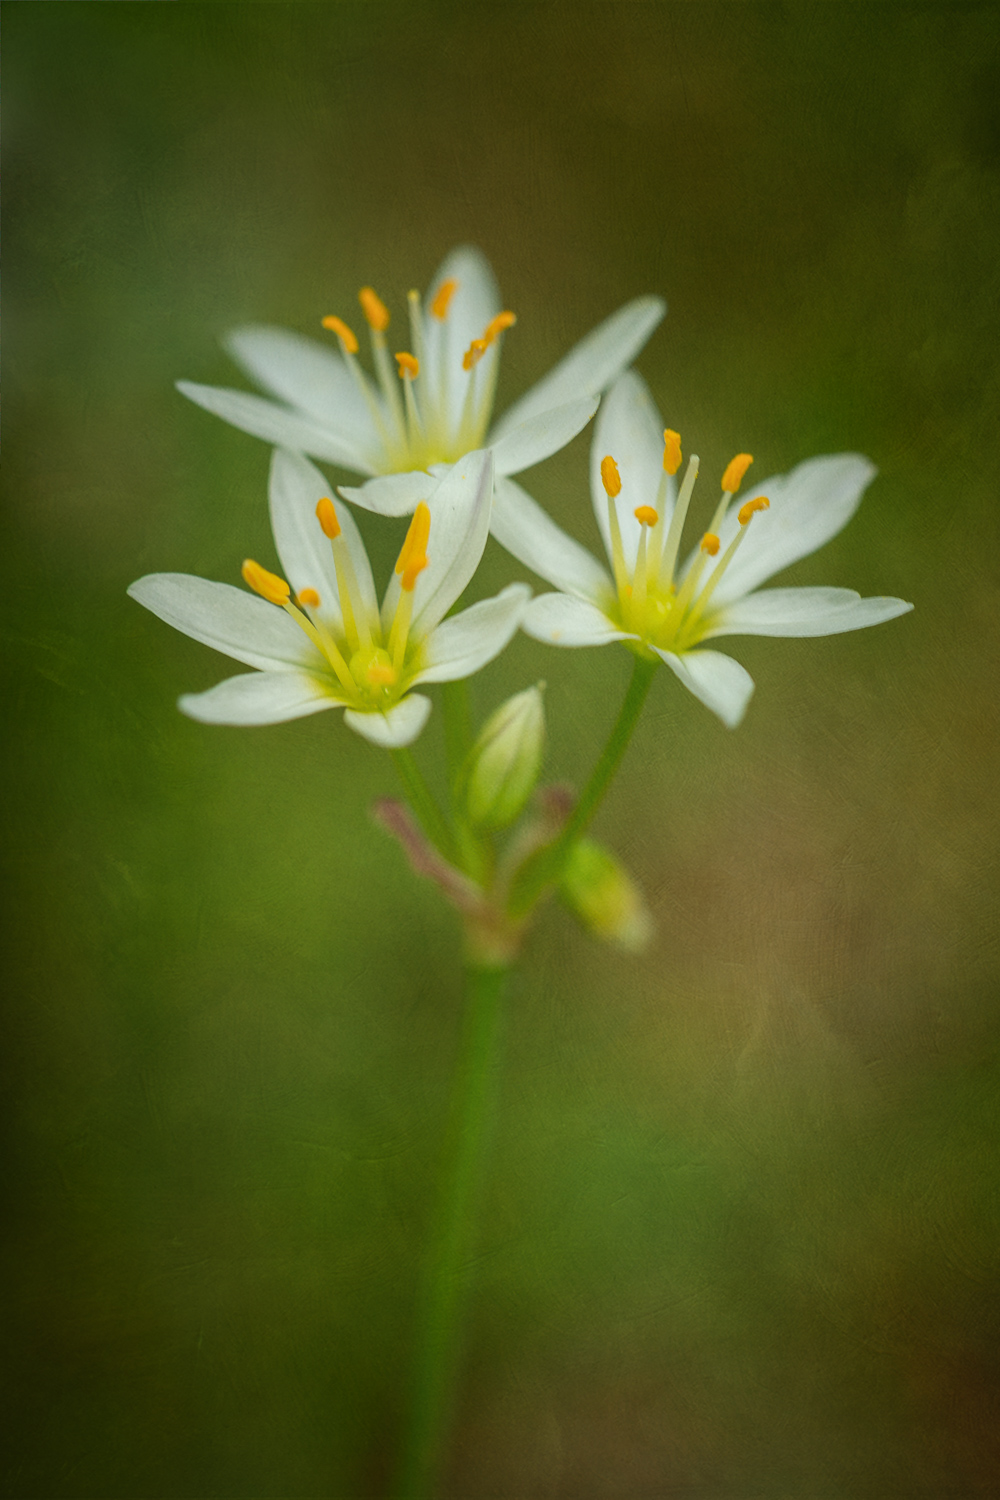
<box><xmin>591</xmin><ymin>371</ymin><xmax>673</xmax><ymax>572</ymax></box>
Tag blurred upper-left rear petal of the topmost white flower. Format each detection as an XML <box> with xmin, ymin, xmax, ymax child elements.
<box><xmin>225</xmin><ymin>324</ymin><xmax>381</xmax><ymax>458</ymax></box>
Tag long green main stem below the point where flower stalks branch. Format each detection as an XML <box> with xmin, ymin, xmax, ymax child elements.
<box><xmin>393</xmin><ymin>966</ymin><xmax>510</xmax><ymax>1500</ymax></box>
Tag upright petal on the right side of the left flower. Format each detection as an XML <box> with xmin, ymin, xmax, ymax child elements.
<box><xmin>410</xmin><ymin>450</ymin><xmax>493</xmax><ymax>638</ymax></box>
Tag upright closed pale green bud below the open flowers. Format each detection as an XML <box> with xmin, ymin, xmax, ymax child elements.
<box><xmin>465</xmin><ymin>683</ymin><xmax>546</xmax><ymax>828</ymax></box>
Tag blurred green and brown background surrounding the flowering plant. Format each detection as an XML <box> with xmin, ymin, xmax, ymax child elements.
<box><xmin>3</xmin><ymin>3</ymin><xmax>1000</xmax><ymax>1500</ymax></box>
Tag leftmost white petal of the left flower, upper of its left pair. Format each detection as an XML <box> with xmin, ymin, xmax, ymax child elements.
<box><xmin>129</xmin><ymin>573</ymin><xmax>324</xmax><ymax>672</ymax></box>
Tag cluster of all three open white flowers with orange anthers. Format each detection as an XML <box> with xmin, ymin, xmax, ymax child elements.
<box><xmin>129</xmin><ymin>249</ymin><xmax>912</xmax><ymax>749</ymax></box>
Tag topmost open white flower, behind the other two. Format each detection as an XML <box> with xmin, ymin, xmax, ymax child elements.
<box><xmin>178</xmin><ymin>246</ymin><xmax>666</xmax><ymax>516</ymax></box>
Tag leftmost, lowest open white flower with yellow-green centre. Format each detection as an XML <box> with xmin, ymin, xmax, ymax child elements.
<box><xmin>129</xmin><ymin>449</ymin><xmax>531</xmax><ymax>749</ymax></box>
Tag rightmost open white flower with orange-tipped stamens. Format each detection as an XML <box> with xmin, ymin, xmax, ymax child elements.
<box><xmin>492</xmin><ymin>371</ymin><xmax>913</xmax><ymax>728</ymax></box>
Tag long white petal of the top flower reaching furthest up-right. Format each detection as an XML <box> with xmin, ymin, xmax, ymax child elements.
<box><xmin>493</xmin><ymin>297</ymin><xmax>667</xmax><ymax>440</ymax></box>
